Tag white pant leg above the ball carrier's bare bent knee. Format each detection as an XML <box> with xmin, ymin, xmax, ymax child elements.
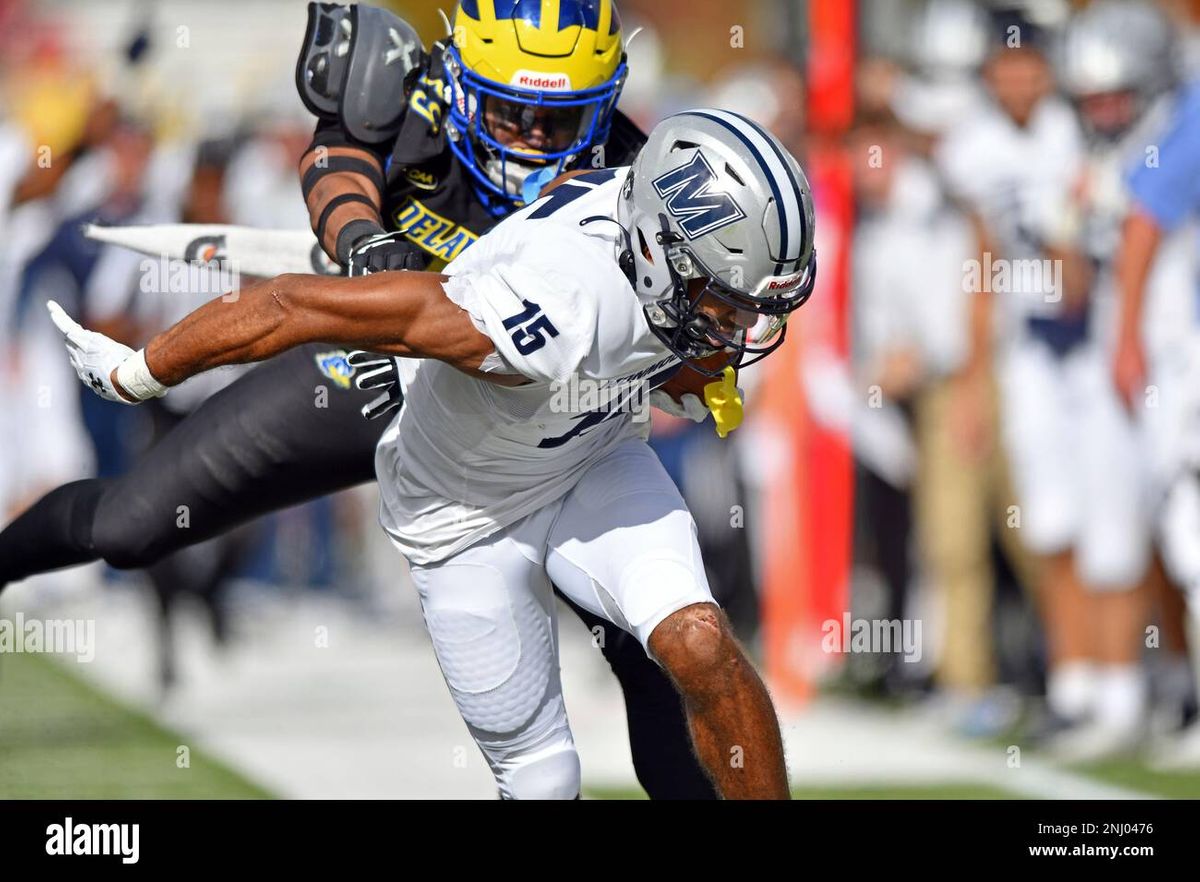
<box><xmin>546</xmin><ymin>439</ymin><xmax>716</xmax><ymax>652</ymax></box>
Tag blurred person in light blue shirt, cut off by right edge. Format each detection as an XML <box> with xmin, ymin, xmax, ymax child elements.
<box><xmin>1112</xmin><ymin>0</ymin><xmax>1200</xmax><ymax>767</ymax></box>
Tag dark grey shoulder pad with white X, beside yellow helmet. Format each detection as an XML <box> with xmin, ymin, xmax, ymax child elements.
<box><xmin>296</xmin><ymin>2</ymin><xmax>425</xmax><ymax>144</ymax></box>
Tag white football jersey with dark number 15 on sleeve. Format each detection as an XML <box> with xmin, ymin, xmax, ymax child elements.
<box><xmin>376</xmin><ymin>168</ymin><xmax>680</xmax><ymax>564</ymax></box>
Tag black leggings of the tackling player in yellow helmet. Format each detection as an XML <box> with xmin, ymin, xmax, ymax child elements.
<box><xmin>0</xmin><ymin>346</ymin><xmax>715</xmax><ymax>799</ymax></box>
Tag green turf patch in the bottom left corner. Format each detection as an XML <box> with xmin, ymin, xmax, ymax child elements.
<box><xmin>0</xmin><ymin>654</ymin><xmax>270</xmax><ymax>799</ymax></box>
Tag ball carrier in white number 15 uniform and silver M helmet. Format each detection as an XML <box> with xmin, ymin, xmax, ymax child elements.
<box><xmin>44</xmin><ymin>110</ymin><xmax>816</xmax><ymax>798</ymax></box>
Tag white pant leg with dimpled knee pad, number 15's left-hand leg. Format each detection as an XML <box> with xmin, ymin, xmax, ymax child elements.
<box><xmin>412</xmin><ymin>504</ymin><xmax>580</xmax><ymax>799</ymax></box>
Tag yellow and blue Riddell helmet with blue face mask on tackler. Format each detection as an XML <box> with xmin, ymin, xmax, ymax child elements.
<box><xmin>443</xmin><ymin>0</ymin><xmax>626</xmax><ymax>211</ymax></box>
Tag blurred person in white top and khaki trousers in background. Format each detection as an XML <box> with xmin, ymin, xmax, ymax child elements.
<box><xmin>850</xmin><ymin>103</ymin><xmax>1004</xmax><ymax>732</ymax></box>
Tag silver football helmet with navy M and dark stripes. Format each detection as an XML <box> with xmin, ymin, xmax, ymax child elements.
<box><xmin>617</xmin><ymin>109</ymin><xmax>816</xmax><ymax>376</ymax></box>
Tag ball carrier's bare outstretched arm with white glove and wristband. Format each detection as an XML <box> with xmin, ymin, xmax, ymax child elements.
<box><xmin>50</xmin><ymin>272</ymin><xmax>510</xmax><ymax>403</ymax></box>
